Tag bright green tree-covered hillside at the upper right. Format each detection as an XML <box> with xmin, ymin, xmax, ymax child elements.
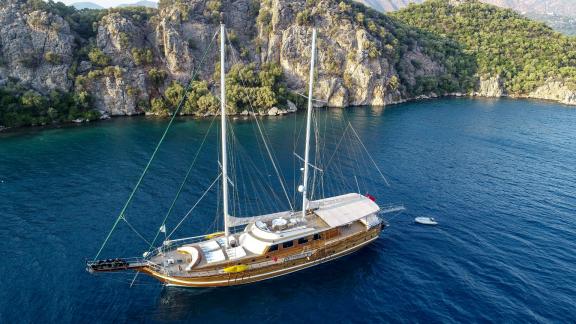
<box><xmin>394</xmin><ymin>0</ymin><xmax>576</xmax><ymax>94</ymax></box>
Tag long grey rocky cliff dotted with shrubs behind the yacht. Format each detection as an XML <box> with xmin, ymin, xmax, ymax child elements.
<box><xmin>0</xmin><ymin>0</ymin><xmax>575</xmax><ymax>127</ymax></box>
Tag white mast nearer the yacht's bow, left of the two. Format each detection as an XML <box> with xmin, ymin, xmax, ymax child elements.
<box><xmin>220</xmin><ymin>22</ymin><xmax>230</xmax><ymax>247</ymax></box>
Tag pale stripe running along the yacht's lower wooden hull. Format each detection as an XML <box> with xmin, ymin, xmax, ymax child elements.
<box><xmin>154</xmin><ymin>236</ymin><xmax>378</xmax><ymax>287</ymax></box>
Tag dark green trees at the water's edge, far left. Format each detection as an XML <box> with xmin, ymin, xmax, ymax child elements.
<box><xmin>0</xmin><ymin>83</ymin><xmax>100</xmax><ymax>127</ymax></box>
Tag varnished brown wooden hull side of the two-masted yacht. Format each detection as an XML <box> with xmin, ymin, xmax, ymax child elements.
<box><xmin>139</xmin><ymin>227</ymin><xmax>381</xmax><ymax>287</ymax></box>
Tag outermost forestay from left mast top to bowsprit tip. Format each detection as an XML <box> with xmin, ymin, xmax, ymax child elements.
<box><xmin>94</xmin><ymin>29</ymin><xmax>218</xmax><ymax>261</ymax></box>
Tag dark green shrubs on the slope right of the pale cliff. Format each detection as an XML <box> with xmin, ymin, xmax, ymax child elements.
<box><xmin>338</xmin><ymin>0</ymin><xmax>476</xmax><ymax>96</ymax></box>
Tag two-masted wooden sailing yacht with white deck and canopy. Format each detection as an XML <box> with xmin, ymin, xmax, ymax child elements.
<box><xmin>87</xmin><ymin>24</ymin><xmax>403</xmax><ymax>287</ymax></box>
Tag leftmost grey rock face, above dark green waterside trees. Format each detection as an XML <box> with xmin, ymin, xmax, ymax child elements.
<box><xmin>0</xmin><ymin>1</ymin><xmax>74</xmax><ymax>93</ymax></box>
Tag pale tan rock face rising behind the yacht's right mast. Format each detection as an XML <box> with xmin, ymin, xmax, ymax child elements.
<box><xmin>258</xmin><ymin>0</ymin><xmax>432</xmax><ymax>107</ymax></box>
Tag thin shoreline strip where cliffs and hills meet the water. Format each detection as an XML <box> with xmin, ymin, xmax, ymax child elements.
<box><xmin>0</xmin><ymin>93</ymin><xmax>576</xmax><ymax>134</ymax></box>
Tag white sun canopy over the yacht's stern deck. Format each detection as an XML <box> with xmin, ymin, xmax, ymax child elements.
<box><xmin>310</xmin><ymin>193</ymin><xmax>380</xmax><ymax>227</ymax></box>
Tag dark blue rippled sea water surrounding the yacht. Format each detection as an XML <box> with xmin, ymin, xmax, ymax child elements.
<box><xmin>0</xmin><ymin>99</ymin><xmax>576</xmax><ymax>323</ymax></box>
